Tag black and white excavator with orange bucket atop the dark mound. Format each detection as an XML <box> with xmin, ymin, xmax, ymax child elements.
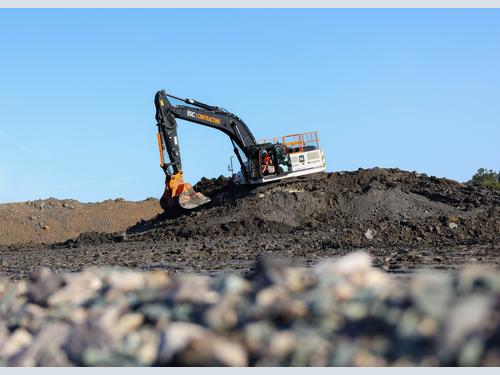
<box><xmin>154</xmin><ymin>90</ymin><xmax>326</xmax><ymax>211</ymax></box>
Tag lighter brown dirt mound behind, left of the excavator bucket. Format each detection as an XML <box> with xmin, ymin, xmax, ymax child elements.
<box><xmin>0</xmin><ymin>198</ymin><xmax>161</xmax><ymax>245</ymax></box>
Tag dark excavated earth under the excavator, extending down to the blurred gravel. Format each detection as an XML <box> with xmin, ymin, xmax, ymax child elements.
<box><xmin>0</xmin><ymin>168</ymin><xmax>500</xmax><ymax>278</ymax></box>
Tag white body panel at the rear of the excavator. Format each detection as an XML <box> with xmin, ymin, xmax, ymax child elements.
<box><xmin>234</xmin><ymin>150</ymin><xmax>326</xmax><ymax>185</ymax></box>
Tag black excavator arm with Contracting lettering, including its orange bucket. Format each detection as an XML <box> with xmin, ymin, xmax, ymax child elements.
<box><xmin>155</xmin><ymin>90</ymin><xmax>257</xmax><ymax>209</ymax></box>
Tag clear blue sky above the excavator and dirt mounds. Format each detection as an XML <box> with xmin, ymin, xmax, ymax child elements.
<box><xmin>0</xmin><ymin>9</ymin><xmax>500</xmax><ymax>202</ymax></box>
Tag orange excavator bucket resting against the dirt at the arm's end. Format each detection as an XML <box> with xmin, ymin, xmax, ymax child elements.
<box><xmin>160</xmin><ymin>172</ymin><xmax>210</xmax><ymax>211</ymax></box>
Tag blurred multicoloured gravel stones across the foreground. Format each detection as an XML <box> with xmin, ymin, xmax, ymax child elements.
<box><xmin>0</xmin><ymin>253</ymin><xmax>500</xmax><ymax>366</ymax></box>
